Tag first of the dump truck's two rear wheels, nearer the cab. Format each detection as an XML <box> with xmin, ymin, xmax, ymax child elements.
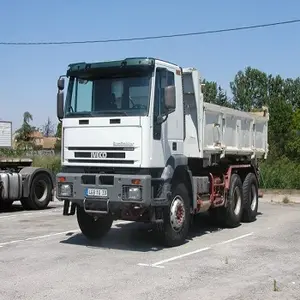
<box><xmin>222</xmin><ymin>174</ymin><xmax>244</xmax><ymax>228</ymax></box>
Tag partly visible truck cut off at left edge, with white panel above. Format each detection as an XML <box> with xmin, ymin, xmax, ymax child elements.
<box><xmin>0</xmin><ymin>121</ymin><xmax>55</xmax><ymax>210</ymax></box>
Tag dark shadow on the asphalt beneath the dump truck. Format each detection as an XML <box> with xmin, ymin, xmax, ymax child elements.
<box><xmin>60</xmin><ymin>213</ymin><xmax>261</xmax><ymax>252</ymax></box>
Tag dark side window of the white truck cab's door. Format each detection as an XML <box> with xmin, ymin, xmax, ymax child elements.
<box><xmin>153</xmin><ymin>68</ymin><xmax>175</xmax><ymax>140</ymax></box>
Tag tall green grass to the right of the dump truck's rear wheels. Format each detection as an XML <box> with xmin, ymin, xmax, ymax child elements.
<box><xmin>260</xmin><ymin>158</ymin><xmax>300</xmax><ymax>189</ymax></box>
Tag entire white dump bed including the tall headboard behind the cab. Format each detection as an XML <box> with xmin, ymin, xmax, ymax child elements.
<box><xmin>183</xmin><ymin>68</ymin><xmax>269</xmax><ymax>158</ymax></box>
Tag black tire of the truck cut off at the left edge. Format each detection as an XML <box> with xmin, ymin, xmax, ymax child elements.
<box><xmin>21</xmin><ymin>172</ymin><xmax>53</xmax><ymax>210</ymax></box>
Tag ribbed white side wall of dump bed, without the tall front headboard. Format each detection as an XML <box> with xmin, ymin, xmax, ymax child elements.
<box><xmin>202</xmin><ymin>102</ymin><xmax>269</xmax><ymax>158</ymax></box>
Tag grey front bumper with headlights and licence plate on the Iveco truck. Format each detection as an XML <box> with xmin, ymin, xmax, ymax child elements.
<box><xmin>56</xmin><ymin>173</ymin><xmax>152</xmax><ymax>212</ymax></box>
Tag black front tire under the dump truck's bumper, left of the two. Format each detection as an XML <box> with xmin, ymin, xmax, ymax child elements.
<box><xmin>77</xmin><ymin>206</ymin><xmax>113</xmax><ymax>240</ymax></box>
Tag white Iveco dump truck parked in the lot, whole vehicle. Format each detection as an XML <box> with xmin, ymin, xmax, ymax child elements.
<box><xmin>56</xmin><ymin>57</ymin><xmax>269</xmax><ymax>246</ymax></box>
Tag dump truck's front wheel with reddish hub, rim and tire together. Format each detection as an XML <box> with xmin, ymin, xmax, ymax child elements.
<box><xmin>158</xmin><ymin>183</ymin><xmax>191</xmax><ymax>247</ymax></box>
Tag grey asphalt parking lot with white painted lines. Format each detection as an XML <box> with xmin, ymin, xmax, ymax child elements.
<box><xmin>0</xmin><ymin>201</ymin><xmax>300</xmax><ymax>300</ymax></box>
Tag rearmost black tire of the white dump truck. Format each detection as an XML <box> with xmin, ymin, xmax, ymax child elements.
<box><xmin>242</xmin><ymin>173</ymin><xmax>258</xmax><ymax>222</ymax></box>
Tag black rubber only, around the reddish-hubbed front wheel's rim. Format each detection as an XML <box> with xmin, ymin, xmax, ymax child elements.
<box><xmin>158</xmin><ymin>183</ymin><xmax>191</xmax><ymax>247</ymax></box>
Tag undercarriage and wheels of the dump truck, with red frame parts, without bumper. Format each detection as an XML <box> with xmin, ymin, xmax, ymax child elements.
<box><xmin>59</xmin><ymin>159</ymin><xmax>259</xmax><ymax>247</ymax></box>
